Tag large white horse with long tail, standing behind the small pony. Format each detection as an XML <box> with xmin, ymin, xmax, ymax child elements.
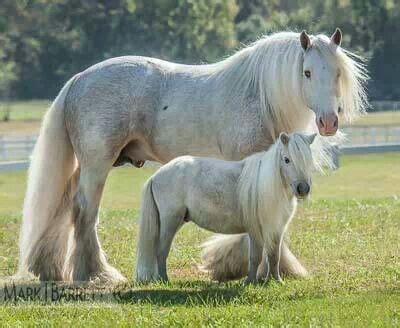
<box><xmin>19</xmin><ymin>30</ymin><xmax>366</xmax><ymax>281</ymax></box>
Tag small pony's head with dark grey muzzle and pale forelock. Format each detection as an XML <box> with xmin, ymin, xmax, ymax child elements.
<box><xmin>276</xmin><ymin>133</ymin><xmax>316</xmax><ymax>198</ymax></box>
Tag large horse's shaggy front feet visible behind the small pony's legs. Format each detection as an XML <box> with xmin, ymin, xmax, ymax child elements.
<box><xmin>199</xmin><ymin>234</ymin><xmax>307</xmax><ymax>281</ymax></box>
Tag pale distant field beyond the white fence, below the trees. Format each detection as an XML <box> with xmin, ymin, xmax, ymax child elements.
<box><xmin>0</xmin><ymin>100</ymin><xmax>400</xmax><ymax>136</ymax></box>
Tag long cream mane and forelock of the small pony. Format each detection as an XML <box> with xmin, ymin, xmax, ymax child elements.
<box><xmin>238</xmin><ymin>133</ymin><xmax>315</xmax><ymax>243</ymax></box>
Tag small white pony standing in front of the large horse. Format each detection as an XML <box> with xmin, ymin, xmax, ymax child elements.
<box><xmin>136</xmin><ymin>133</ymin><xmax>315</xmax><ymax>283</ymax></box>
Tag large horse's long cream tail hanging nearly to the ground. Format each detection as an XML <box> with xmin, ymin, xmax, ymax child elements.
<box><xmin>17</xmin><ymin>77</ymin><xmax>75</xmax><ymax>278</ymax></box>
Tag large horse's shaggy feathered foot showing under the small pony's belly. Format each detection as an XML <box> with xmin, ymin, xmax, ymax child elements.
<box><xmin>199</xmin><ymin>234</ymin><xmax>249</xmax><ymax>281</ymax></box>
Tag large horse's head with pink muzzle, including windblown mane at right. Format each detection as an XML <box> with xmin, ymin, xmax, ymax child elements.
<box><xmin>299</xmin><ymin>28</ymin><xmax>367</xmax><ymax>136</ymax></box>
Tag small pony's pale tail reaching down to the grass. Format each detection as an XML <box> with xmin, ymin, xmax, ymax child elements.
<box><xmin>136</xmin><ymin>179</ymin><xmax>160</xmax><ymax>282</ymax></box>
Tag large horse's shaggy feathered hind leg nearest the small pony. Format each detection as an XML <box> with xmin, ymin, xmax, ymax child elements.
<box><xmin>69</xmin><ymin>164</ymin><xmax>125</xmax><ymax>282</ymax></box>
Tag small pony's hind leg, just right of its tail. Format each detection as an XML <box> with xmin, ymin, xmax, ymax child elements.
<box><xmin>157</xmin><ymin>213</ymin><xmax>184</xmax><ymax>281</ymax></box>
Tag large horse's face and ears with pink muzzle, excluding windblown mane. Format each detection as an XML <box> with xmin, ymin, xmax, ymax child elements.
<box><xmin>300</xmin><ymin>29</ymin><xmax>342</xmax><ymax>136</ymax></box>
